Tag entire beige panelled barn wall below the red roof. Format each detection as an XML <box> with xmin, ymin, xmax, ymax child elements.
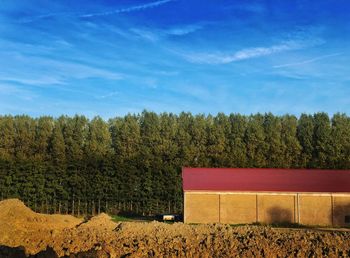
<box><xmin>184</xmin><ymin>192</ymin><xmax>350</xmax><ymax>226</ymax></box>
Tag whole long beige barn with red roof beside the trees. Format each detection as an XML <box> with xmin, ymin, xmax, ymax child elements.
<box><xmin>182</xmin><ymin>168</ymin><xmax>350</xmax><ymax>226</ymax></box>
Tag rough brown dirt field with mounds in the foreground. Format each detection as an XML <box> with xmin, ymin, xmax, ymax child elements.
<box><xmin>0</xmin><ymin>199</ymin><xmax>350</xmax><ymax>257</ymax></box>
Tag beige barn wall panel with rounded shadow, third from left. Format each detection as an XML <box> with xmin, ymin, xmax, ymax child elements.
<box><xmin>257</xmin><ymin>194</ymin><xmax>296</xmax><ymax>223</ymax></box>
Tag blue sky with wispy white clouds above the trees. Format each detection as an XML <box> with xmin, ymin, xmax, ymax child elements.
<box><xmin>0</xmin><ymin>0</ymin><xmax>350</xmax><ymax>118</ymax></box>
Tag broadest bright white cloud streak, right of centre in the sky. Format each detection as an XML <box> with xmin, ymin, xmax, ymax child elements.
<box><xmin>182</xmin><ymin>38</ymin><xmax>324</xmax><ymax>64</ymax></box>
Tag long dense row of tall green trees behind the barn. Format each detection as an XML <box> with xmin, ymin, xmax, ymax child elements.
<box><xmin>0</xmin><ymin>111</ymin><xmax>350</xmax><ymax>215</ymax></box>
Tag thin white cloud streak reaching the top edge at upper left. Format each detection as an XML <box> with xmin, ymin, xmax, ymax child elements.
<box><xmin>19</xmin><ymin>0</ymin><xmax>174</xmax><ymax>23</ymax></box>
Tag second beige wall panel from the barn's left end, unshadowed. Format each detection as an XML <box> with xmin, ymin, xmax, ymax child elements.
<box><xmin>220</xmin><ymin>194</ymin><xmax>256</xmax><ymax>224</ymax></box>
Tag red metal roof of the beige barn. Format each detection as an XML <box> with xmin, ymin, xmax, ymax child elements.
<box><xmin>182</xmin><ymin>168</ymin><xmax>350</xmax><ymax>193</ymax></box>
